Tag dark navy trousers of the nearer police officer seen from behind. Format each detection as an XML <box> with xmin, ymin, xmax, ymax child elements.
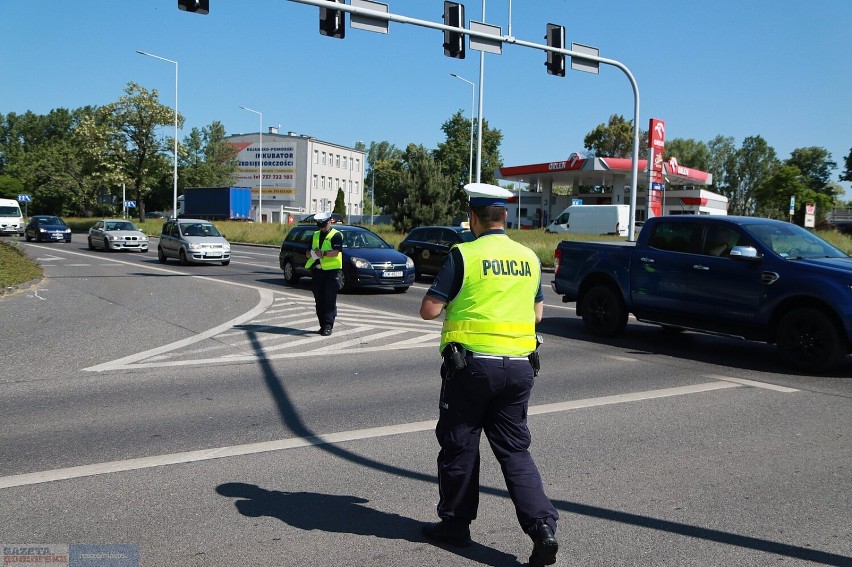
<box><xmin>435</xmin><ymin>354</ymin><xmax>559</xmax><ymax>533</ymax></box>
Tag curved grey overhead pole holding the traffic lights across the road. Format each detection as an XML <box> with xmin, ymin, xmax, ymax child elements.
<box><xmin>289</xmin><ymin>0</ymin><xmax>639</xmax><ymax>240</ymax></box>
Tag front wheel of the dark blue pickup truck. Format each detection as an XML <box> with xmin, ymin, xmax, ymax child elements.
<box><xmin>777</xmin><ymin>307</ymin><xmax>847</xmax><ymax>374</ymax></box>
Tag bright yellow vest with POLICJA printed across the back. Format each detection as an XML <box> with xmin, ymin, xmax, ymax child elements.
<box><xmin>440</xmin><ymin>234</ymin><xmax>541</xmax><ymax>356</ymax></box>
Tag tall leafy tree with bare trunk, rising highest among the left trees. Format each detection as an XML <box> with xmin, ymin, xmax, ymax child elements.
<box><xmin>106</xmin><ymin>82</ymin><xmax>183</xmax><ymax>219</ymax></box>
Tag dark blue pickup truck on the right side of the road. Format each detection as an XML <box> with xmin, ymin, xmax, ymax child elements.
<box><xmin>552</xmin><ymin>215</ymin><xmax>852</xmax><ymax>374</ymax></box>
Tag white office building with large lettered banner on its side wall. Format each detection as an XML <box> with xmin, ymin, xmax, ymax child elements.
<box><xmin>226</xmin><ymin>128</ymin><xmax>366</xmax><ymax>223</ymax></box>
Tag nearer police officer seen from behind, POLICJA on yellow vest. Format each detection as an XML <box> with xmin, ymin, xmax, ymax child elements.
<box><xmin>420</xmin><ymin>183</ymin><xmax>559</xmax><ymax>566</ymax></box>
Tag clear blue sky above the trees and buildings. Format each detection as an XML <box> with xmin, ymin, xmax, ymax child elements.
<box><xmin>0</xmin><ymin>0</ymin><xmax>852</xmax><ymax>195</ymax></box>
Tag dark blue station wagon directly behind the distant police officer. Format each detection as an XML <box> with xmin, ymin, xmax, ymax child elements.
<box><xmin>278</xmin><ymin>225</ymin><xmax>414</xmax><ymax>292</ymax></box>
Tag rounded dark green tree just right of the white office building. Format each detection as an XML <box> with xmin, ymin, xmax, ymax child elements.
<box><xmin>391</xmin><ymin>144</ymin><xmax>458</xmax><ymax>232</ymax></box>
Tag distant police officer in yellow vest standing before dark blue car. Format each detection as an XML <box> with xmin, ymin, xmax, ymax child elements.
<box><xmin>305</xmin><ymin>213</ymin><xmax>343</xmax><ymax>337</ymax></box>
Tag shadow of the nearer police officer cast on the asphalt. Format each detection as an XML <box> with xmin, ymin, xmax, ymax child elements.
<box><xmin>216</xmin><ymin>482</ymin><xmax>520</xmax><ymax>566</ymax></box>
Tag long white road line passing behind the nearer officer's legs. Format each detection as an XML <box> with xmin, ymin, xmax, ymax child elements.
<box><xmin>0</xmin><ymin>382</ymin><xmax>772</xmax><ymax>490</ymax></box>
